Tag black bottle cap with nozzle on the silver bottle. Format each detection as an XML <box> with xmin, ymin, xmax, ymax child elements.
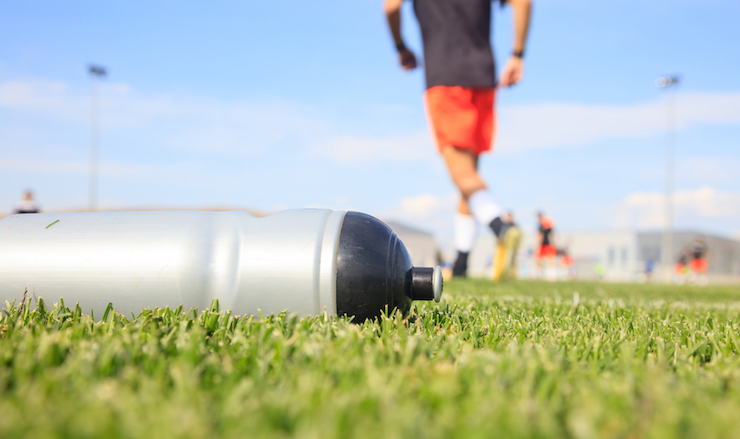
<box><xmin>336</xmin><ymin>212</ymin><xmax>442</xmax><ymax>323</ymax></box>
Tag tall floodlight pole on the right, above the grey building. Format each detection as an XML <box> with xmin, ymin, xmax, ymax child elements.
<box><xmin>655</xmin><ymin>75</ymin><xmax>679</xmax><ymax>282</ymax></box>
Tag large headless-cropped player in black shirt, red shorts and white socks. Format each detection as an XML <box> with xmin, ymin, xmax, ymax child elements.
<box><xmin>385</xmin><ymin>0</ymin><xmax>531</xmax><ymax>276</ymax></box>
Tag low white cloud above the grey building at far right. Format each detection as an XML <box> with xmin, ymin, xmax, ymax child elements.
<box><xmin>611</xmin><ymin>186</ymin><xmax>740</xmax><ymax>229</ymax></box>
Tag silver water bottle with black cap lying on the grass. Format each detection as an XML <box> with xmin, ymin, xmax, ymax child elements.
<box><xmin>0</xmin><ymin>209</ymin><xmax>442</xmax><ymax>322</ymax></box>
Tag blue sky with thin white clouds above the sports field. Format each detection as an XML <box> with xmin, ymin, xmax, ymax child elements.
<box><xmin>0</xmin><ymin>0</ymin><xmax>740</xmax><ymax>251</ymax></box>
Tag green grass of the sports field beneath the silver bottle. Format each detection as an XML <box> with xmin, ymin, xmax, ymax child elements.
<box><xmin>0</xmin><ymin>280</ymin><xmax>740</xmax><ymax>439</ymax></box>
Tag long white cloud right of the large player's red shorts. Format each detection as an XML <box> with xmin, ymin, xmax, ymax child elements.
<box><xmin>496</xmin><ymin>92</ymin><xmax>740</xmax><ymax>152</ymax></box>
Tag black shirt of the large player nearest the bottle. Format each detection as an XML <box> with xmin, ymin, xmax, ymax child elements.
<box><xmin>414</xmin><ymin>0</ymin><xmax>496</xmax><ymax>88</ymax></box>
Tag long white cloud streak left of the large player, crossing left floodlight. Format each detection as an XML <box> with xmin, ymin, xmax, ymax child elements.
<box><xmin>0</xmin><ymin>81</ymin><xmax>434</xmax><ymax>162</ymax></box>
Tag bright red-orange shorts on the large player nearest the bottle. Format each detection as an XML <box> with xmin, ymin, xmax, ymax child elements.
<box><xmin>424</xmin><ymin>85</ymin><xmax>496</xmax><ymax>155</ymax></box>
